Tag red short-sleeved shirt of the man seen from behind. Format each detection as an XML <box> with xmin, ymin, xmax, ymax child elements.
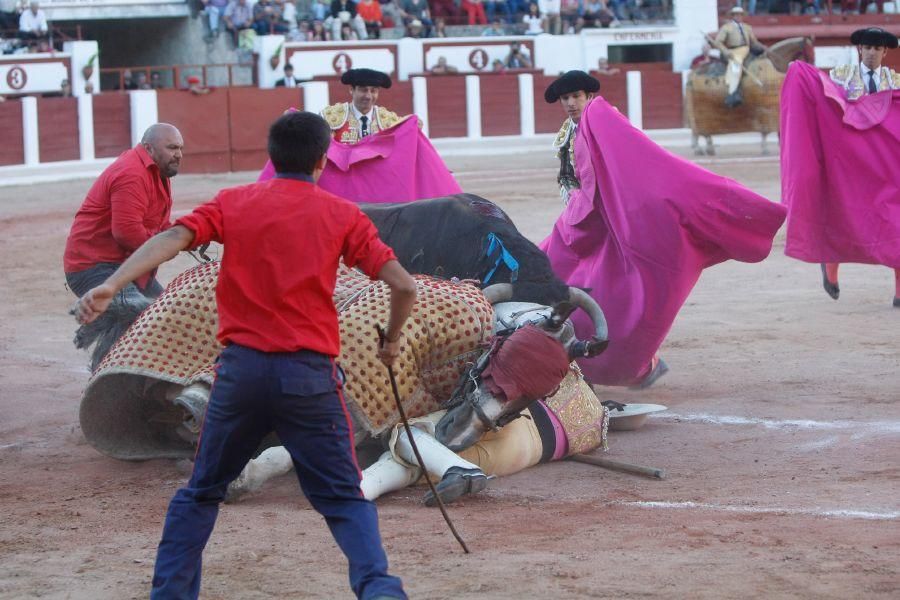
<box><xmin>175</xmin><ymin>178</ymin><xmax>396</xmax><ymax>356</ymax></box>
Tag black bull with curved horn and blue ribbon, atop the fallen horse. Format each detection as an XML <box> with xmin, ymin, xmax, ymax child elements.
<box><xmin>361</xmin><ymin>194</ymin><xmax>608</xmax><ymax>355</ymax></box>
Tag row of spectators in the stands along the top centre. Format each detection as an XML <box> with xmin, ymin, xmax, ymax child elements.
<box><xmin>200</xmin><ymin>0</ymin><xmax>671</xmax><ymax>43</ymax></box>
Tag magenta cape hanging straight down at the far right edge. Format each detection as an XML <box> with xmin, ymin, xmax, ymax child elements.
<box><xmin>781</xmin><ymin>62</ymin><xmax>900</xmax><ymax>269</ymax></box>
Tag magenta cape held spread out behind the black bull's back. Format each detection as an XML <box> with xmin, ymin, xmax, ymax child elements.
<box><xmin>259</xmin><ymin>117</ymin><xmax>462</xmax><ymax>202</ymax></box>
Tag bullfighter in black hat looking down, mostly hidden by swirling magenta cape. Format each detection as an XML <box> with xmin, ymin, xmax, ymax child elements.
<box><xmin>544</xmin><ymin>71</ymin><xmax>600</xmax><ymax>204</ymax></box>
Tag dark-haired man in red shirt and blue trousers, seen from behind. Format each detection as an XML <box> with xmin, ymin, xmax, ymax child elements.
<box><xmin>76</xmin><ymin>112</ymin><xmax>416</xmax><ymax>599</ymax></box>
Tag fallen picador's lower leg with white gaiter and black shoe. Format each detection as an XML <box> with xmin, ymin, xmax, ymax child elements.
<box><xmin>395</xmin><ymin>427</ymin><xmax>488</xmax><ymax>506</ymax></box>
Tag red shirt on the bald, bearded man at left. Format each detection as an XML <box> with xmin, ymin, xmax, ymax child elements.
<box><xmin>63</xmin><ymin>145</ymin><xmax>172</xmax><ymax>285</ymax></box>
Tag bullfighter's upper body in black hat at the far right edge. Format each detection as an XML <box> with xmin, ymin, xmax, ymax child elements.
<box><xmin>829</xmin><ymin>27</ymin><xmax>900</xmax><ymax>100</ymax></box>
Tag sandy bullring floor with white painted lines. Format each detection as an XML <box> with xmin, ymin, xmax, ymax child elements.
<box><xmin>0</xmin><ymin>139</ymin><xmax>900</xmax><ymax>598</ymax></box>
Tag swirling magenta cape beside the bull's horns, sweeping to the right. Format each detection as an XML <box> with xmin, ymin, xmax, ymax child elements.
<box><xmin>541</xmin><ymin>98</ymin><xmax>786</xmax><ymax>385</ymax></box>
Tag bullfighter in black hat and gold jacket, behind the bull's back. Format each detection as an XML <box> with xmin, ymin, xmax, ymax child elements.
<box><xmin>322</xmin><ymin>69</ymin><xmax>403</xmax><ymax>144</ymax></box>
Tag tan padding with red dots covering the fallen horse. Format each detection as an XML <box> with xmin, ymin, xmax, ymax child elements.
<box><xmin>86</xmin><ymin>262</ymin><xmax>493</xmax><ymax>434</ymax></box>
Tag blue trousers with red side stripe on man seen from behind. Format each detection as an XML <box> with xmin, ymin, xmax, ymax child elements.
<box><xmin>150</xmin><ymin>344</ymin><xmax>406</xmax><ymax>600</ymax></box>
